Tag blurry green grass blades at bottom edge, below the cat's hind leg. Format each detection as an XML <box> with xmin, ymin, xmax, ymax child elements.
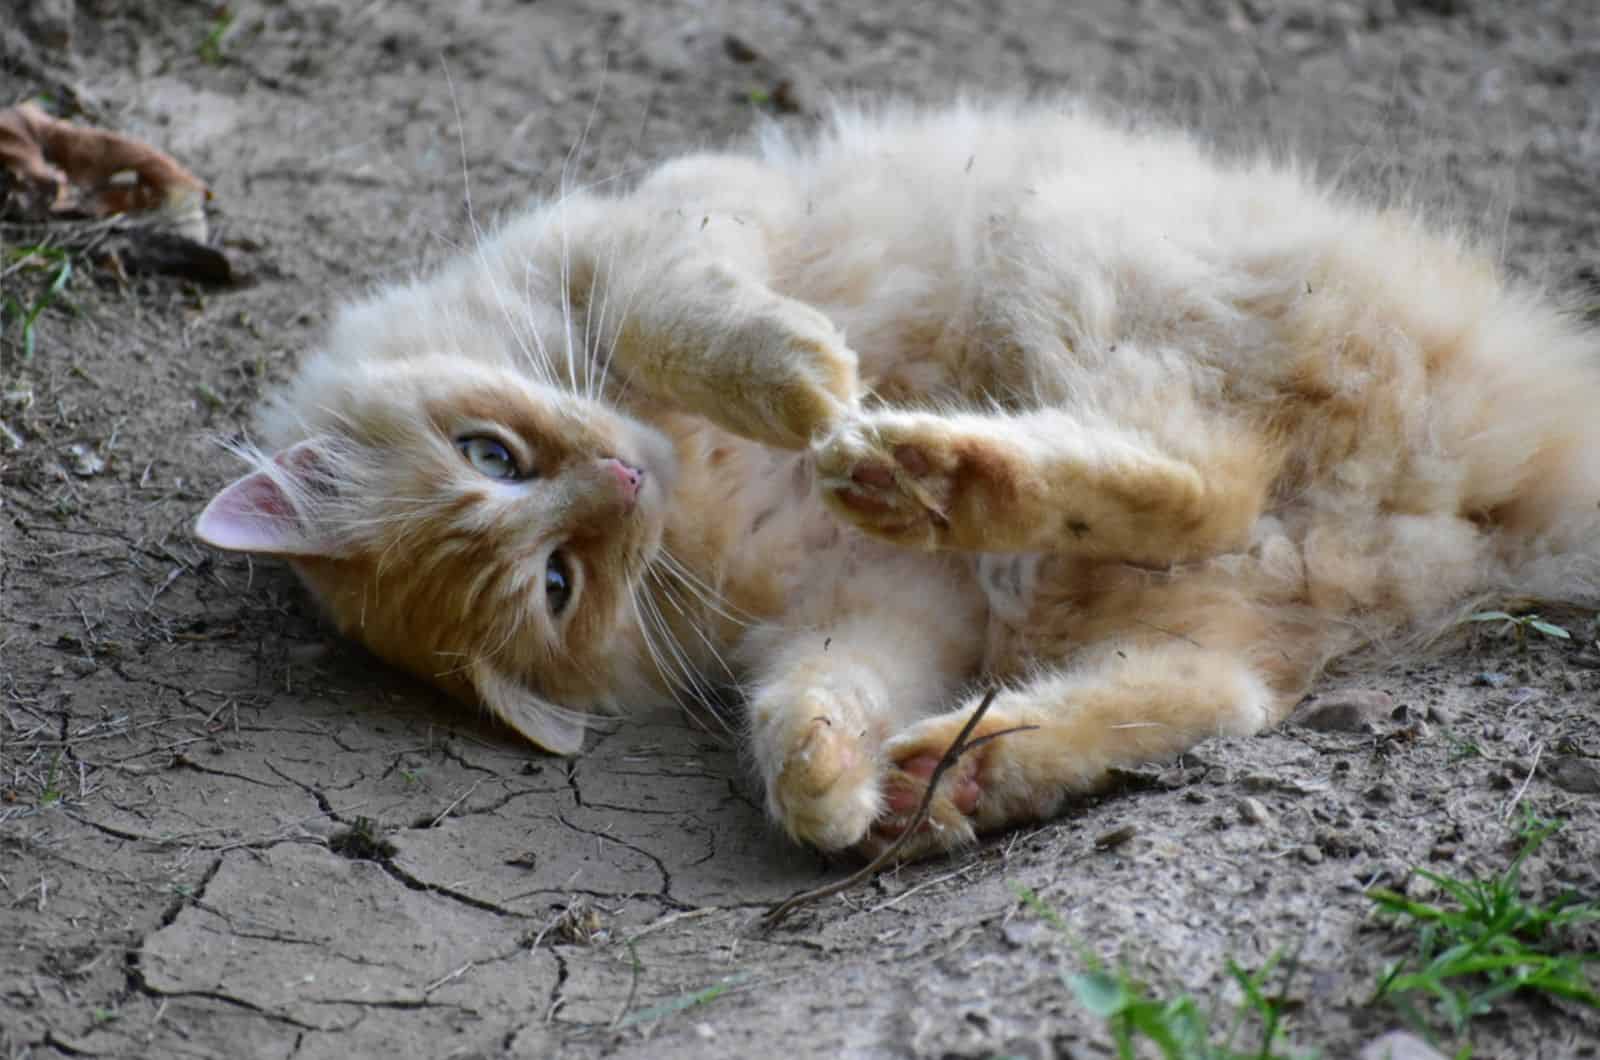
<box><xmin>1014</xmin><ymin>885</ymin><xmax>1312</xmax><ymax>1060</ymax></box>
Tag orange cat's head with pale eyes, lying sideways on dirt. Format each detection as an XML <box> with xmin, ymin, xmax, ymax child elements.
<box><xmin>195</xmin><ymin>357</ymin><xmax>675</xmax><ymax>754</ymax></box>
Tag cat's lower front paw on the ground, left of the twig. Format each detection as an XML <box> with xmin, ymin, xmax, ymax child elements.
<box><xmin>768</xmin><ymin>690</ymin><xmax>882</xmax><ymax>850</ymax></box>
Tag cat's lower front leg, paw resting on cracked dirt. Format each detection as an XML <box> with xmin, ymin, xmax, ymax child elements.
<box><xmin>749</xmin><ymin>570</ymin><xmax>981</xmax><ymax>850</ymax></box>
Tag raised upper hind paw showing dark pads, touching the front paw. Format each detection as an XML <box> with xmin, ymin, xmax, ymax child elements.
<box><xmin>814</xmin><ymin>412</ymin><xmax>963</xmax><ymax>549</ymax></box>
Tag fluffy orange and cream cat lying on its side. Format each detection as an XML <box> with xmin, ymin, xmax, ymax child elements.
<box><xmin>197</xmin><ymin>102</ymin><xmax>1600</xmax><ymax>857</ymax></box>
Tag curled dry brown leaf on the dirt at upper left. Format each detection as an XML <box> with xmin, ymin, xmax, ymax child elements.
<box><xmin>0</xmin><ymin>102</ymin><xmax>211</xmax><ymax>237</ymax></box>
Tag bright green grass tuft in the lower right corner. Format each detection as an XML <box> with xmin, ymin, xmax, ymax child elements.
<box><xmin>1366</xmin><ymin>815</ymin><xmax>1600</xmax><ymax>1038</ymax></box>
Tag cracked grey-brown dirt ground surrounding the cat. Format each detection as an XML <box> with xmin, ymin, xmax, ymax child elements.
<box><xmin>0</xmin><ymin>0</ymin><xmax>1600</xmax><ymax>1058</ymax></box>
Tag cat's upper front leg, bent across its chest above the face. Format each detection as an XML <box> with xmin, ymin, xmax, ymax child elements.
<box><xmin>566</xmin><ymin>164</ymin><xmax>858</xmax><ymax>448</ymax></box>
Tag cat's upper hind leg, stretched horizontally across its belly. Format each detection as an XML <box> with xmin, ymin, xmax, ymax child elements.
<box><xmin>816</xmin><ymin>408</ymin><xmax>1277</xmax><ymax>567</ymax></box>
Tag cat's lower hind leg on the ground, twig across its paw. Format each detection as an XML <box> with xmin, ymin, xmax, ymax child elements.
<box><xmin>867</xmin><ymin>560</ymin><xmax>1324</xmax><ymax>857</ymax></box>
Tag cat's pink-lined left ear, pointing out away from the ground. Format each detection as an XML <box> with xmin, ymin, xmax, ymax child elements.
<box><xmin>195</xmin><ymin>442</ymin><xmax>339</xmax><ymax>556</ymax></box>
